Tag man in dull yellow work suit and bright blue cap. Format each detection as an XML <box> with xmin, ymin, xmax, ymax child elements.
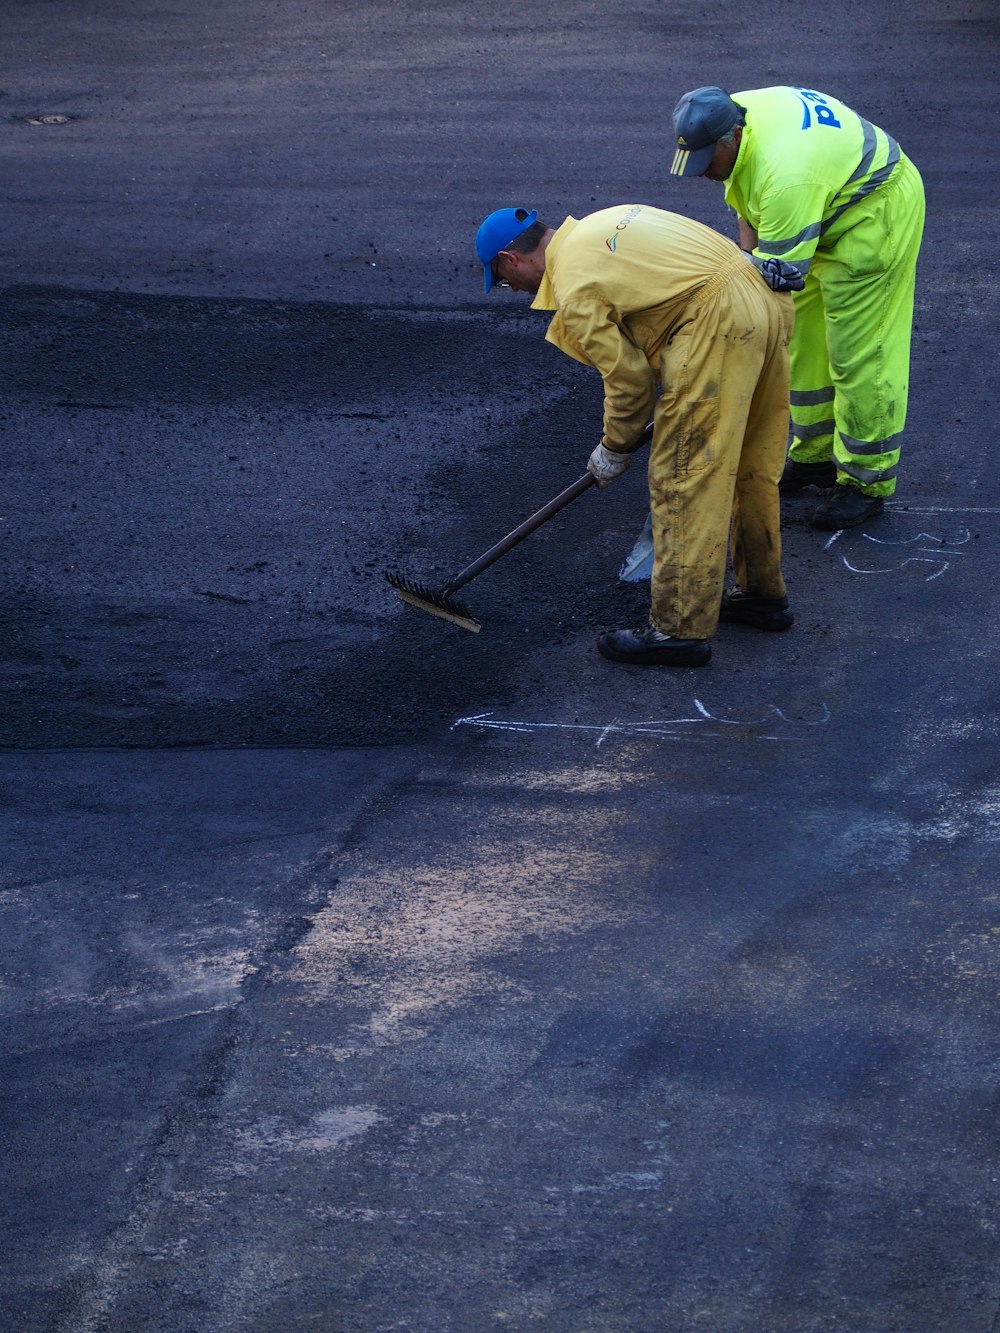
<box><xmin>476</xmin><ymin>204</ymin><xmax>795</xmax><ymax>667</ymax></box>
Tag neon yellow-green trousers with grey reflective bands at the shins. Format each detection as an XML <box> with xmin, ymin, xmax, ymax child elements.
<box><xmin>788</xmin><ymin>156</ymin><xmax>924</xmax><ymax>496</ymax></box>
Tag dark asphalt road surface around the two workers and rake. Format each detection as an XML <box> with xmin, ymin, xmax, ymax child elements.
<box><xmin>0</xmin><ymin>0</ymin><xmax>1000</xmax><ymax>1333</ymax></box>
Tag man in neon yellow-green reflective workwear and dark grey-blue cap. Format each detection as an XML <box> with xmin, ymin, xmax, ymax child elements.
<box><xmin>671</xmin><ymin>87</ymin><xmax>924</xmax><ymax>531</ymax></box>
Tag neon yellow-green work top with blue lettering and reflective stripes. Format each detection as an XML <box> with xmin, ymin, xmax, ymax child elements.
<box><xmin>725</xmin><ymin>88</ymin><xmax>900</xmax><ymax>273</ymax></box>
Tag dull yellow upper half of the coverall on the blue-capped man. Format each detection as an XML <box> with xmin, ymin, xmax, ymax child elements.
<box><xmin>532</xmin><ymin>204</ymin><xmax>749</xmax><ymax>453</ymax></box>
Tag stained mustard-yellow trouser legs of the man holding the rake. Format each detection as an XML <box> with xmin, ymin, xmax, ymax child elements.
<box><xmin>649</xmin><ymin>257</ymin><xmax>795</xmax><ymax>639</ymax></box>
